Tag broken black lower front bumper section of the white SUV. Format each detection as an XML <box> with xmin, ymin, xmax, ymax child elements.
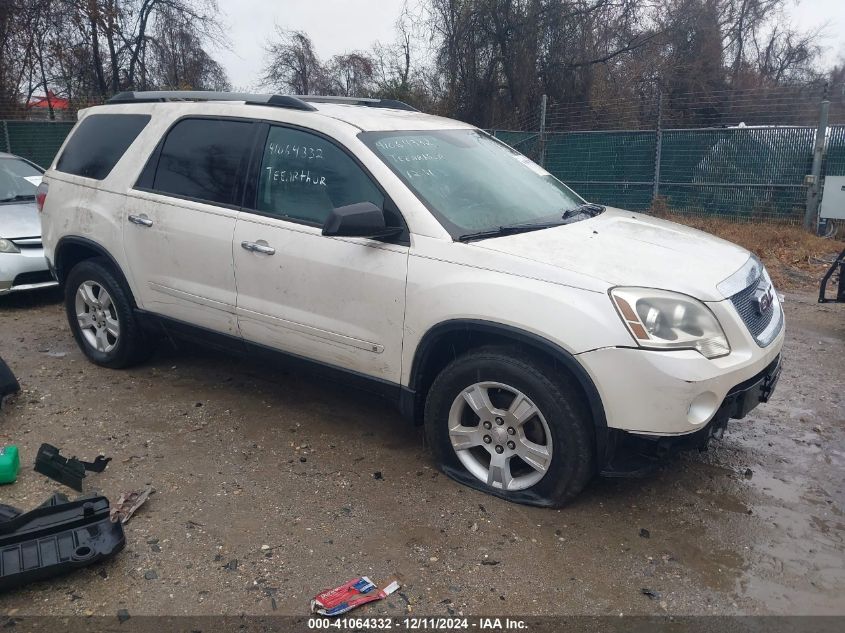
<box><xmin>601</xmin><ymin>355</ymin><xmax>781</xmax><ymax>477</ymax></box>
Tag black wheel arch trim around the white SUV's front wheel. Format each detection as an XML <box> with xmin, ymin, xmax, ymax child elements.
<box><xmin>408</xmin><ymin>319</ymin><xmax>608</xmax><ymax>461</ymax></box>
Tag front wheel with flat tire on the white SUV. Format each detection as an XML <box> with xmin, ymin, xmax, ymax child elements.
<box><xmin>425</xmin><ymin>347</ymin><xmax>596</xmax><ymax>507</ymax></box>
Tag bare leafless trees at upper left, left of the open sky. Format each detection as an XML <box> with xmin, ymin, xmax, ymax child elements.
<box><xmin>0</xmin><ymin>0</ymin><xmax>228</xmax><ymax>105</ymax></box>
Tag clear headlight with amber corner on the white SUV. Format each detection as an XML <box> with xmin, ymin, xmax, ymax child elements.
<box><xmin>610</xmin><ymin>288</ymin><xmax>731</xmax><ymax>358</ymax></box>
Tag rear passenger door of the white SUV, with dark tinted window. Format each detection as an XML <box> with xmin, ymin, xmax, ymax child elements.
<box><xmin>123</xmin><ymin>117</ymin><xmax>256</xmax><ymax>335</ymax></box>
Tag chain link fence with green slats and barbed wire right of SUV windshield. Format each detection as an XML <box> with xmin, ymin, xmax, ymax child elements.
<box><xmin>491</xmin><ymin>81</ymin><xmax>845</xmax><ymax>224</ymax></box>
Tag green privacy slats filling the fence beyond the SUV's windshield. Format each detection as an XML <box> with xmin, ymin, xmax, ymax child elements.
<box><xmin>488</xmin><ymin>126</ymin><xmax>824</xmax><ymax>222</ymax></box>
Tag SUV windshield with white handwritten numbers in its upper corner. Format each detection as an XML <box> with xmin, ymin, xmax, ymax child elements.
<box><xmin>360</xmin><ymin>129</ymin><xmax>584</xmax><ymax>239</ymax></box>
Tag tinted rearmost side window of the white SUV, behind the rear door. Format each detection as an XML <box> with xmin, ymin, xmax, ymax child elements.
<box><xmin>56</xmin><ymin>114</ymin><xmax>150</xmax><ymax>180</ymax></box>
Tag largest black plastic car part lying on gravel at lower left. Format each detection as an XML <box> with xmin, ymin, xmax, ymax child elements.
<box><xmin>0</xmin><ymin>494</ymin><xmax>126</xmax><ymax>591</ymax></box>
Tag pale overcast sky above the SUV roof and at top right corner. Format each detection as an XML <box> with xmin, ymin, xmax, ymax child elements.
<box><xmin>215</xmin><ymin>0</ymin><xmax>845</xmax><ymax>90</ymax></box>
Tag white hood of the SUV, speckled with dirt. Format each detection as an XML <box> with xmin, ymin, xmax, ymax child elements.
<box><xmin>472</xmin><ymin>209</ymin><xmax>750</xmax><ymax>301</ymax></box>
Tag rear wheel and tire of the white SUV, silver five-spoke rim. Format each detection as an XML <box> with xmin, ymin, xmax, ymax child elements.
<box><xmin>65</xmin><ymin>257</ymin><xmax>153</xmax><ymax>369</ymax></box>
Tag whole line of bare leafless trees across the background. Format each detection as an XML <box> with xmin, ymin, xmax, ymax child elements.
<box><xmin>0</xmin><ymin>0</ymin><xmax>842</xmax><ymax>127</ymax></box>
